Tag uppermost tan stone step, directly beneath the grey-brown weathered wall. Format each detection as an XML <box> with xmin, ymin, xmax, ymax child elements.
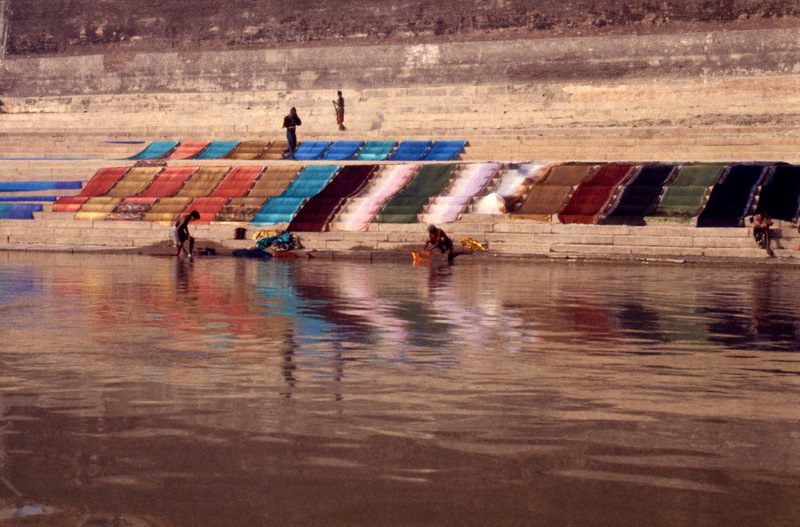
<box><xmin>4</xmin><ymin>75</ymin><xmax>797</xmax><ymax>113</ymax></box>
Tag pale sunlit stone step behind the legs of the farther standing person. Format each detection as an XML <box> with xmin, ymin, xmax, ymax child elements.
<box><xmin>4</xmin><ymin>90</ymin><xmax>800</xmax><ymax>126</ymax></box>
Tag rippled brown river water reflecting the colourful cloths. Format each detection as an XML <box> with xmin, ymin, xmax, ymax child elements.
<box><xmin>0</xmin><ymin>252</ymin><xmax>800</xmax><ymax>527</ymax></box>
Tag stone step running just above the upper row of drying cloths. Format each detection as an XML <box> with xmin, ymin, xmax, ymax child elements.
<box><xmin>0</xmin><ymin>126</ymin><xmax>800</xmax><ymax>143</ymax></box>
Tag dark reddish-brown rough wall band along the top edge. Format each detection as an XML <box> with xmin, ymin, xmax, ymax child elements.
<box><xmin>8</xmin><ymin>0</ymin><xmax>800</xmax><ymax>56</ymax></box>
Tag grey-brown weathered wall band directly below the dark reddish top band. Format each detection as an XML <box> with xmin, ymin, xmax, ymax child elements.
<box><xmin>0</xmin><ymin>29</ymin><xmax>800</xmax><ymax>98</ymax></box>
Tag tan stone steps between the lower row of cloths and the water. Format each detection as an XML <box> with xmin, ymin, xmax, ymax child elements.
<box><xmin>0</xmin><ymin>212</ymin><xmax>800</xmax><ymax>258</ymax></box>
